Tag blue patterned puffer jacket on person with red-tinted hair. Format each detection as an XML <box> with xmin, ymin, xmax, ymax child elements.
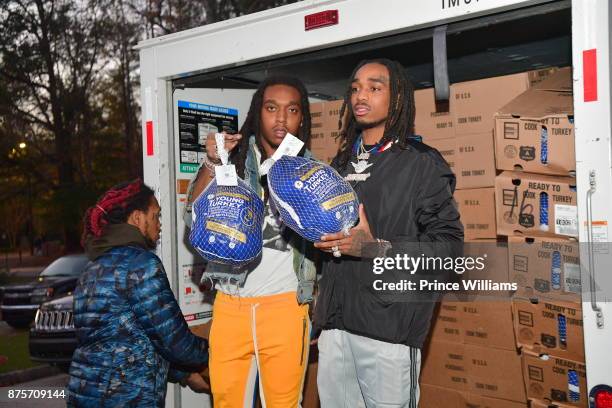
<box><xmin>68</xmin><ymin>246</ymin><xmax>208</xmax><ymax>407</ymax></box>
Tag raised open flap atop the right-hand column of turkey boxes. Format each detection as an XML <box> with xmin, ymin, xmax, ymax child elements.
<box><xmin>497</xmin><ymin>69</ymin><xmax>574</xmax><ymax>119</ymax></box>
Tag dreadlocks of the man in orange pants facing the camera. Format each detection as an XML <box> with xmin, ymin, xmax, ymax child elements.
<box><xmin>230</xmin><ymin>76</ymin><xmax>310</xmax><ymax>177</ymax></box>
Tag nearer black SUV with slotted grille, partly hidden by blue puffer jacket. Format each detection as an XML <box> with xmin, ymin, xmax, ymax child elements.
<box><xmin>29</xmin><ymin>295</ymin><xmax>77</xmax><ymax>368</ymax></box>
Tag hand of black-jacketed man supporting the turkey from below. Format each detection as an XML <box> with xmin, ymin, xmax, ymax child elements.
<box><xmin>314</xmin><ymin>204</ymin><xmax>376</xmax><ymax>257</ymax></box>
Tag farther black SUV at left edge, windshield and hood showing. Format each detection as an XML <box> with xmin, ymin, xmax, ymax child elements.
<box><xmin>1</xmin><ymin>254</ymin><xmax>88</xmax><ymax>327</ymax></box>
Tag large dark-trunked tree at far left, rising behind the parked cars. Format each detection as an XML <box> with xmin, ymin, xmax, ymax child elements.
<box><xmin>0</xmin><ymin>0</ymin><xmax>108</xmax><ymax>248</ymax></box>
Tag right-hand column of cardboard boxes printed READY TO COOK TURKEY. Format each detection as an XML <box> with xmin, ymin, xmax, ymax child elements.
<box><xmin>495</xmin><ymin>68</ymin><xmax>588</xmax><ymax>408</ymax></box>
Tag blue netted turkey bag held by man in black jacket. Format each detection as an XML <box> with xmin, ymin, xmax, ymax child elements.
<box><xmin>268</xmin><ymin>156</ymin><xmax>359</xmax><ymax>242</ymax></box>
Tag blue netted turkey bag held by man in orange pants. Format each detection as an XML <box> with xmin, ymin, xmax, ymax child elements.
<box><xmin>189</xmin><ymin>179</ymin><xmax>264</xmax><ymax>266</ymax></box>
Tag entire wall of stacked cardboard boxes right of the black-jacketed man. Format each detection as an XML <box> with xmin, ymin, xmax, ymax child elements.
<box><xmin>415</xmin><ymin>68</ymin><xmax>586</xmax><ymax>408</ymax></box>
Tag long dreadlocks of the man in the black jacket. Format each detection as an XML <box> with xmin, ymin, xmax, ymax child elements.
<box><xmin>333</xmin><ymin>58</ymin><xmax>415</xmax><ymax>169</ymax></box>
